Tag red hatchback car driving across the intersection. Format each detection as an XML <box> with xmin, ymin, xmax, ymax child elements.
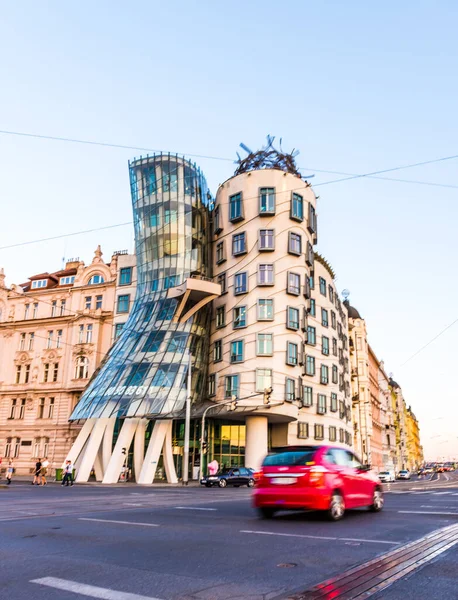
<box><xmin>253</xmin><ymin>446</ymin><xmax>383</xmax><ymax>521</ymax></box>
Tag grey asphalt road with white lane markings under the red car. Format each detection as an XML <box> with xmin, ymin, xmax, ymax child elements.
<box><xmin>0</xmin><ymin>474</ymin><xmax>458</xmax><ymax>600</ymax></box>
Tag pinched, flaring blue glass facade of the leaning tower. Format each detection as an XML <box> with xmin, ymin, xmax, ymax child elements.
<box><xmin>71</xmin><ymin>154</ymin><xmax>211</xmax><ymax>420</ymax></box>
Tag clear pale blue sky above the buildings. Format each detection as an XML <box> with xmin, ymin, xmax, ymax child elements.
<box><xmin>0</xmin><ymin>0</ymin><xmax>458</xmax><ymax>459</ymax></box>
